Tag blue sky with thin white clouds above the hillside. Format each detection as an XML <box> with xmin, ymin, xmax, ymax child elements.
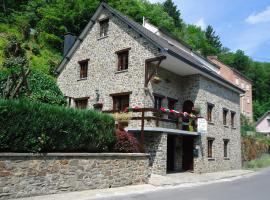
<box><xmin>150</xmin><ymin>0</ymin><xmax>270</xmax><ymax>62</ymax></box>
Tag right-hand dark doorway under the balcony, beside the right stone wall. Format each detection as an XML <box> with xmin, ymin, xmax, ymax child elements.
<box><xmin>183</xmin><ymin>136</ymin><xmax>194</xmax><ymax>171</ymax></box>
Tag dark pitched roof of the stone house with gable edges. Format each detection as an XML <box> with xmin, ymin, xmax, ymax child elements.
<box><xmin>56</xmin><ymin>2</ymin><xmax>245</xmax><ymax>93</ymax></box>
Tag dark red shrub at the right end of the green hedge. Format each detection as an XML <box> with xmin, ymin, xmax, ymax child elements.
<box><xmin>114</xmin><ymin>130</ymin><xmax>141</xmax><ymax>153</ymax></box>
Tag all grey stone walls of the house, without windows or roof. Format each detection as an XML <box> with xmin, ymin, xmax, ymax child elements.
<box><xmin>57</xmin><ymin>4</ymin><xmax>241</xmax><ymax>174</ymax></box>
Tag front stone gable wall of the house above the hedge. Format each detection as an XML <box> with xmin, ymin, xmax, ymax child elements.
<box><xmin>57</xmin><ymin>9</ymin><xmax>159</xmax><ymax>110</ymax></box>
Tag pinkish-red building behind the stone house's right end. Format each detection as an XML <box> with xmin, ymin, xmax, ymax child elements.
<box><xmin>208</xmin><ymin>56</ymin><xmax>253</xmax><ymax>122</ymax></box>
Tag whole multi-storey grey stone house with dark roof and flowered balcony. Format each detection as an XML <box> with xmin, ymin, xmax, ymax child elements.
<box><xmin>56</xmin><ymin>3</ymin><xmax>244</xmax><ymax>174</ymax></box>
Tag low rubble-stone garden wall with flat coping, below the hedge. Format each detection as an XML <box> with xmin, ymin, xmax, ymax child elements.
<box><xmin>0</xmin><ymin>153</ymin><xmax>149</xmax><ymax>199</ymax></box>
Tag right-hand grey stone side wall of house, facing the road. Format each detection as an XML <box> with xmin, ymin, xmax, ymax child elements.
<box><xmin>195</xmin><ymin>76</ymin><xmax>241</xmax><ymax>172</ymax></box>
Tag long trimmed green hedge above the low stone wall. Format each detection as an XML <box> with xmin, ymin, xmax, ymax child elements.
<box><xmin>0</xmin><ymin>99</ymin><xmax>115</xmax><ymax>152</ymax></box>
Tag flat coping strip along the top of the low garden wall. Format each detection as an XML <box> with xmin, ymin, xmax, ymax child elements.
<box><xmin>0</xmin><ymin>153</ymin><xmax>150</xmax><ymax>158</ymax></box>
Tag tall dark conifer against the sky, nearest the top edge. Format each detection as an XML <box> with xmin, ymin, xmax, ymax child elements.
<box><xmin>163</xmin><ymin>0</ymin><xmax>183</xmax><ymax>29</ymax></box>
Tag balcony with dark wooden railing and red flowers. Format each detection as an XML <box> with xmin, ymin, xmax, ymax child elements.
<box><xmin>103</xmin><ymin>107</ymin><xmax>197</xmax><ymax>133</ymax></box>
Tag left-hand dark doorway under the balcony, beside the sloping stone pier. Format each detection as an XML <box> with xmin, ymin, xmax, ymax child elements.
<box><xmin>167</xmin><ymin>135</ymin><xmax>175</xmax><ymax>172</ymax></box>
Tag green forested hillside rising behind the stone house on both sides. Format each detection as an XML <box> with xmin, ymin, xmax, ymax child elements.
<box><xmin>0</xmin><ymin>0</ymin><xmax>270</xmax><ymax>119</ymax></box>
